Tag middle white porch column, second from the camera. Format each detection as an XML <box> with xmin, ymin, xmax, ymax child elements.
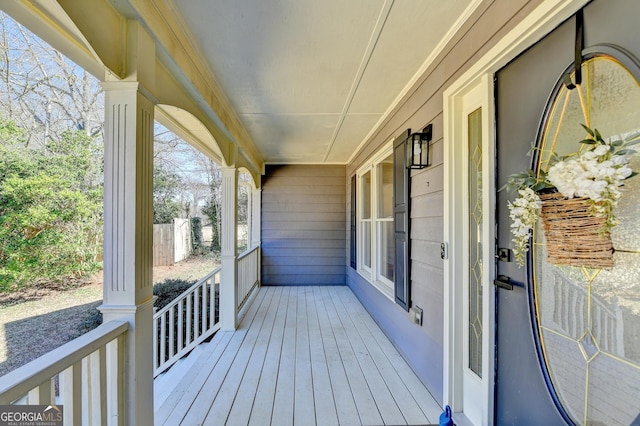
<box><xmin>220</xmin><ymin>167</ymin><xmax>238</xmax><ymax>331</ymax></box>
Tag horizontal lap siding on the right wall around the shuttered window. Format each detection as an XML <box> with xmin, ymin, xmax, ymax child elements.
<box><xmin>345</xmin><ymin>0</ymin><xmax>541</xmax><ymax>401</ymax></box>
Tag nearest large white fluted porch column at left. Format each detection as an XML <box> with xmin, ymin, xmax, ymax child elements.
<box><xmin>100</xmin><ymin>81</ymin><xmax>154</xmax><ymax>425</ymax></box>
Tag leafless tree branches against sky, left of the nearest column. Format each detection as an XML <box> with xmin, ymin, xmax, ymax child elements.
<box><xmin>0</xmin><ymin>12</ymin><xmax>104</xmax><ymax>148</ymax></box>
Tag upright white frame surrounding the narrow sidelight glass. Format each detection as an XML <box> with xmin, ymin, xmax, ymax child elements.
<box><xmin>445</xmin><ymin>74</ymin><xmax>495</xmax><ymax>424</ymax></box>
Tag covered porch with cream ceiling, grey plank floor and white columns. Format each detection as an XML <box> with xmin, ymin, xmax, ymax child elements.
<box><xmin>0</xmin><ymin>0</ymin><xmax>616</xmax><ymax>425</ymax></box>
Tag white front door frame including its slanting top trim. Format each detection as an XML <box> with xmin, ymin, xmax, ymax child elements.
<box><xmin>443</xmin><ymin>0</ymin><xmax>588</xmax><ymax>424</ymax></box>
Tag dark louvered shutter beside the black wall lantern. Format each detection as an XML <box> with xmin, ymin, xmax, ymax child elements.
<box><xmin>393</xmin><ymin>130</ymin><xmax>411</xmax><ymax>311</ymax></box>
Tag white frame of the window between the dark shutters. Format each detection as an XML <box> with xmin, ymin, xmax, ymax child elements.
<box><xmin>356</xmin><ymin>141</ymin><xmax>394</xmax><ymax>300</ymax></box>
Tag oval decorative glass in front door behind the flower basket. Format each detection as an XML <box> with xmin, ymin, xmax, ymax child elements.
<box><xmin>533</xmin><ymin>56</ymin><xmax>640</xmax><ymax>425</ymax></box>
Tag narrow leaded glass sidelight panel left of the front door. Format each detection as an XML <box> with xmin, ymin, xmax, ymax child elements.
<box><xmin>467</xmin><ymin>108</ymin><xmax>482</xmax><ymax>377</ymax></box>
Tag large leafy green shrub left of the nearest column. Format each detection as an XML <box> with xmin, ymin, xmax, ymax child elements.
<box><xmin>0</xmin><ymin>126</ymin><xmax>102</xmax><ymax>292</ymax></box>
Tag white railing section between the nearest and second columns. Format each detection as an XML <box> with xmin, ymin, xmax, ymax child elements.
<box><xmin>153</xmin><ymin>267</ymin><xmax>221</xmax><ymax>377</ymax></box>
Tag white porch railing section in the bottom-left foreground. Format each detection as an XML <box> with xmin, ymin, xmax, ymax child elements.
<box><xmin>0</xmin><ymin>321</ymin><xmax>129</xmax><ymax>425</ymax></box>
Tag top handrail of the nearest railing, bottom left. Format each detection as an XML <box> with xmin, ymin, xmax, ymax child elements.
<box><xmin>0</xmin><ymin>321</ymin><xmax>129</xmax><ymax>404</ymax></box>
